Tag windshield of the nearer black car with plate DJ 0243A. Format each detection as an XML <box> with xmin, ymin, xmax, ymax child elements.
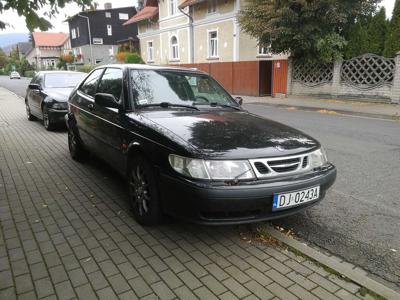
<box><xmin>130</xmin><ymin>70</ymin><xmax>238</xmax><ymax>107</ymax></box>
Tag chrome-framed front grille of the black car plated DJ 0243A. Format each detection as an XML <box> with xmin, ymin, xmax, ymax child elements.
<box><xmin>250</xmin><ymin>154</ymin><xmax>309</xmax><ymax>178</ymax></box>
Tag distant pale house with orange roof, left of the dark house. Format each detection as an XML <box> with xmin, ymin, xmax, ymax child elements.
<box><xmin>25</xmin><ymin>32</ymin><xmax>72</xmax><ymax>69</ymax></box>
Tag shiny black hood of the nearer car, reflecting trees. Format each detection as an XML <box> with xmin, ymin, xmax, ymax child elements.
<box><xmin>134</xmin><ymin>111</ymin><xmax>320</xmax><ymax>159</ymax></box>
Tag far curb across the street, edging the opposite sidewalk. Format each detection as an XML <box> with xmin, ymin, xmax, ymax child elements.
<box><xmin>244</xmin><ymin>102</ymin><xmax>400</xmax><ymax>121</ymax></box>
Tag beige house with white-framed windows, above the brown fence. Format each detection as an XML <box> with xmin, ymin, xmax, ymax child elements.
<box><xmin>126</xmin><ymin>0</ymin><xmax>287</xmax><ymax>64</ymax></box>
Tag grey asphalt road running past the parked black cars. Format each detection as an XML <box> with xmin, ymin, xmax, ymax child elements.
<box><xmin>0</xmin><ymin>76</ymin><xmax>400</xmax><ymax>287</ymax></box>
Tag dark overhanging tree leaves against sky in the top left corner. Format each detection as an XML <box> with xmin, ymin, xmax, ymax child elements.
<box><xmin>0</xmin><ymin>0</ymin><xmax>94</xmax><ymax>31</ymax></box>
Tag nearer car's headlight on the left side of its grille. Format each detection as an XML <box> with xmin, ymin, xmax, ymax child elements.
<box><xmin>168</xmin><ymin>154</ymin><xmax>255</xmax><ymax>180</ymax></box>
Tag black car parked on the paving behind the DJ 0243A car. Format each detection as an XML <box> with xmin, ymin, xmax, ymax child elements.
<box><xmin>25</xmin><ymin>71</ymin><xmax>87</xmax><ymax>130</ymax></box>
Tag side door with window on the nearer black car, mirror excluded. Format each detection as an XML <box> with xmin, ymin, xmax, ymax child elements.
<box><xmin>94</xmin><ymin>67</ymin><xmax>124</xmax><ymax>170</ymax></box>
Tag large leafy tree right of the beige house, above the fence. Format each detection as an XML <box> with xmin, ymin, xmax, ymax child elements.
<box><xmin>239</xmin><ymin>0</ymin><xmax>380</xmax><ymax>62</ymax></box>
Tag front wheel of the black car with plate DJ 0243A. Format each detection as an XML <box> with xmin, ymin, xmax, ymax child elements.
<box><xmin>128</xmin><ymin>155</ymin><xmax>163</xmax><ymax>226</ymax></box>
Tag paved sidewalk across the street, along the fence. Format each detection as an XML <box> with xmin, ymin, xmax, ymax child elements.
<box><xmin>241</xmin><ymin>96</ymin><xmax>400</xmax><ymax>119</ymax></box>
